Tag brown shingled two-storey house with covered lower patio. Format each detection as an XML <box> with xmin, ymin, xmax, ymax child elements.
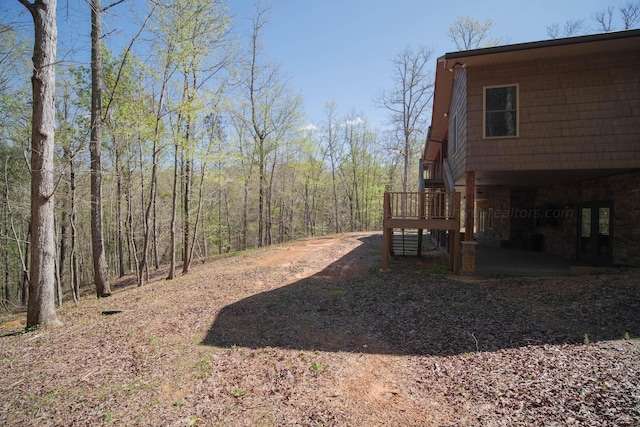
<box><xmin>420</xmin><ymin>30</ymin><xmax>640</xmax><ymax>273</ymax></box>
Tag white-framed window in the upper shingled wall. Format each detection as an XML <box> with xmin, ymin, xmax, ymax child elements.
<box><xmin>484</xmin><ymin>85</ymin><xmax>518</xmax><ymax>138</ymax></box>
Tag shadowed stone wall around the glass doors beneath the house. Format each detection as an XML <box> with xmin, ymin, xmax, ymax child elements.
<box><xmin>536</xmin><ymin>171</ymin><xmax>640</xmax><ymax>266</ymax></box>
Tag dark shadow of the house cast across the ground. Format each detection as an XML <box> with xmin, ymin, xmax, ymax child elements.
<box><xmin>203</xmin><ymin>235</ymin><xmax>640</xmax><ymax>356</ymax></box>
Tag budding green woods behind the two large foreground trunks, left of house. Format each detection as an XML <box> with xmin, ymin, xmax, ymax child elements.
<box><xmin>0</xmin><ymin>0</ymin><xmax>420</xmax><ymax>320</ymax></box>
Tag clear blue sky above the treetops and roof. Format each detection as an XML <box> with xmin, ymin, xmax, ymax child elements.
<box><xmin>0</xmin><ymin>0</ymin><xmax>626</xmax><ymax>128</ymax></box>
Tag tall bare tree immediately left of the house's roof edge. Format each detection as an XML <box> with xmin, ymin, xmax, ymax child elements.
<box><xmin>376</xmin><ymin>46</ymin><xmax>433</xmax><ymax>191</ymax></box>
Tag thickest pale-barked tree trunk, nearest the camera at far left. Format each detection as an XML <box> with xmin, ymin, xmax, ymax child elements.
<box><xmin>18</xmin><ymin>0</ymin><xmax>62</xmax><ymax>328</ymax></box>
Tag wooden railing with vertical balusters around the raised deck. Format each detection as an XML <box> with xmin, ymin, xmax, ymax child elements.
<box><xmin>384</xmin><ymin>191</ymin><xmax>458</xmax><ymax>220</ymax></box>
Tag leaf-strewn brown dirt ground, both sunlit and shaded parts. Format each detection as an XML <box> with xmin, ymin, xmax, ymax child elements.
<box><xmin>0</xmin><ymin>233</ymin><xmax>640</xmax><ymax>426</ymax></box>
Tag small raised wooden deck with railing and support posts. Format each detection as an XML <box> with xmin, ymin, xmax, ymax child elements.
<box><xmin>382</xmin><ymin>190</ymin><xmax>460</xmax><ymax>272</ymax></box>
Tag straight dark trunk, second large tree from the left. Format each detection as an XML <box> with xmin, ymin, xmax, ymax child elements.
<box><xmin>89</xmin><ymin>0</ymin><xmax>111</xmax><ymax>298</ymax></box>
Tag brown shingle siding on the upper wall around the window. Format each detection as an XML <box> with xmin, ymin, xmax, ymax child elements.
<box><xmin>460</xmin><ymin>53</ymin><xmax>640</xmax><ymax>175</ymax></box>
